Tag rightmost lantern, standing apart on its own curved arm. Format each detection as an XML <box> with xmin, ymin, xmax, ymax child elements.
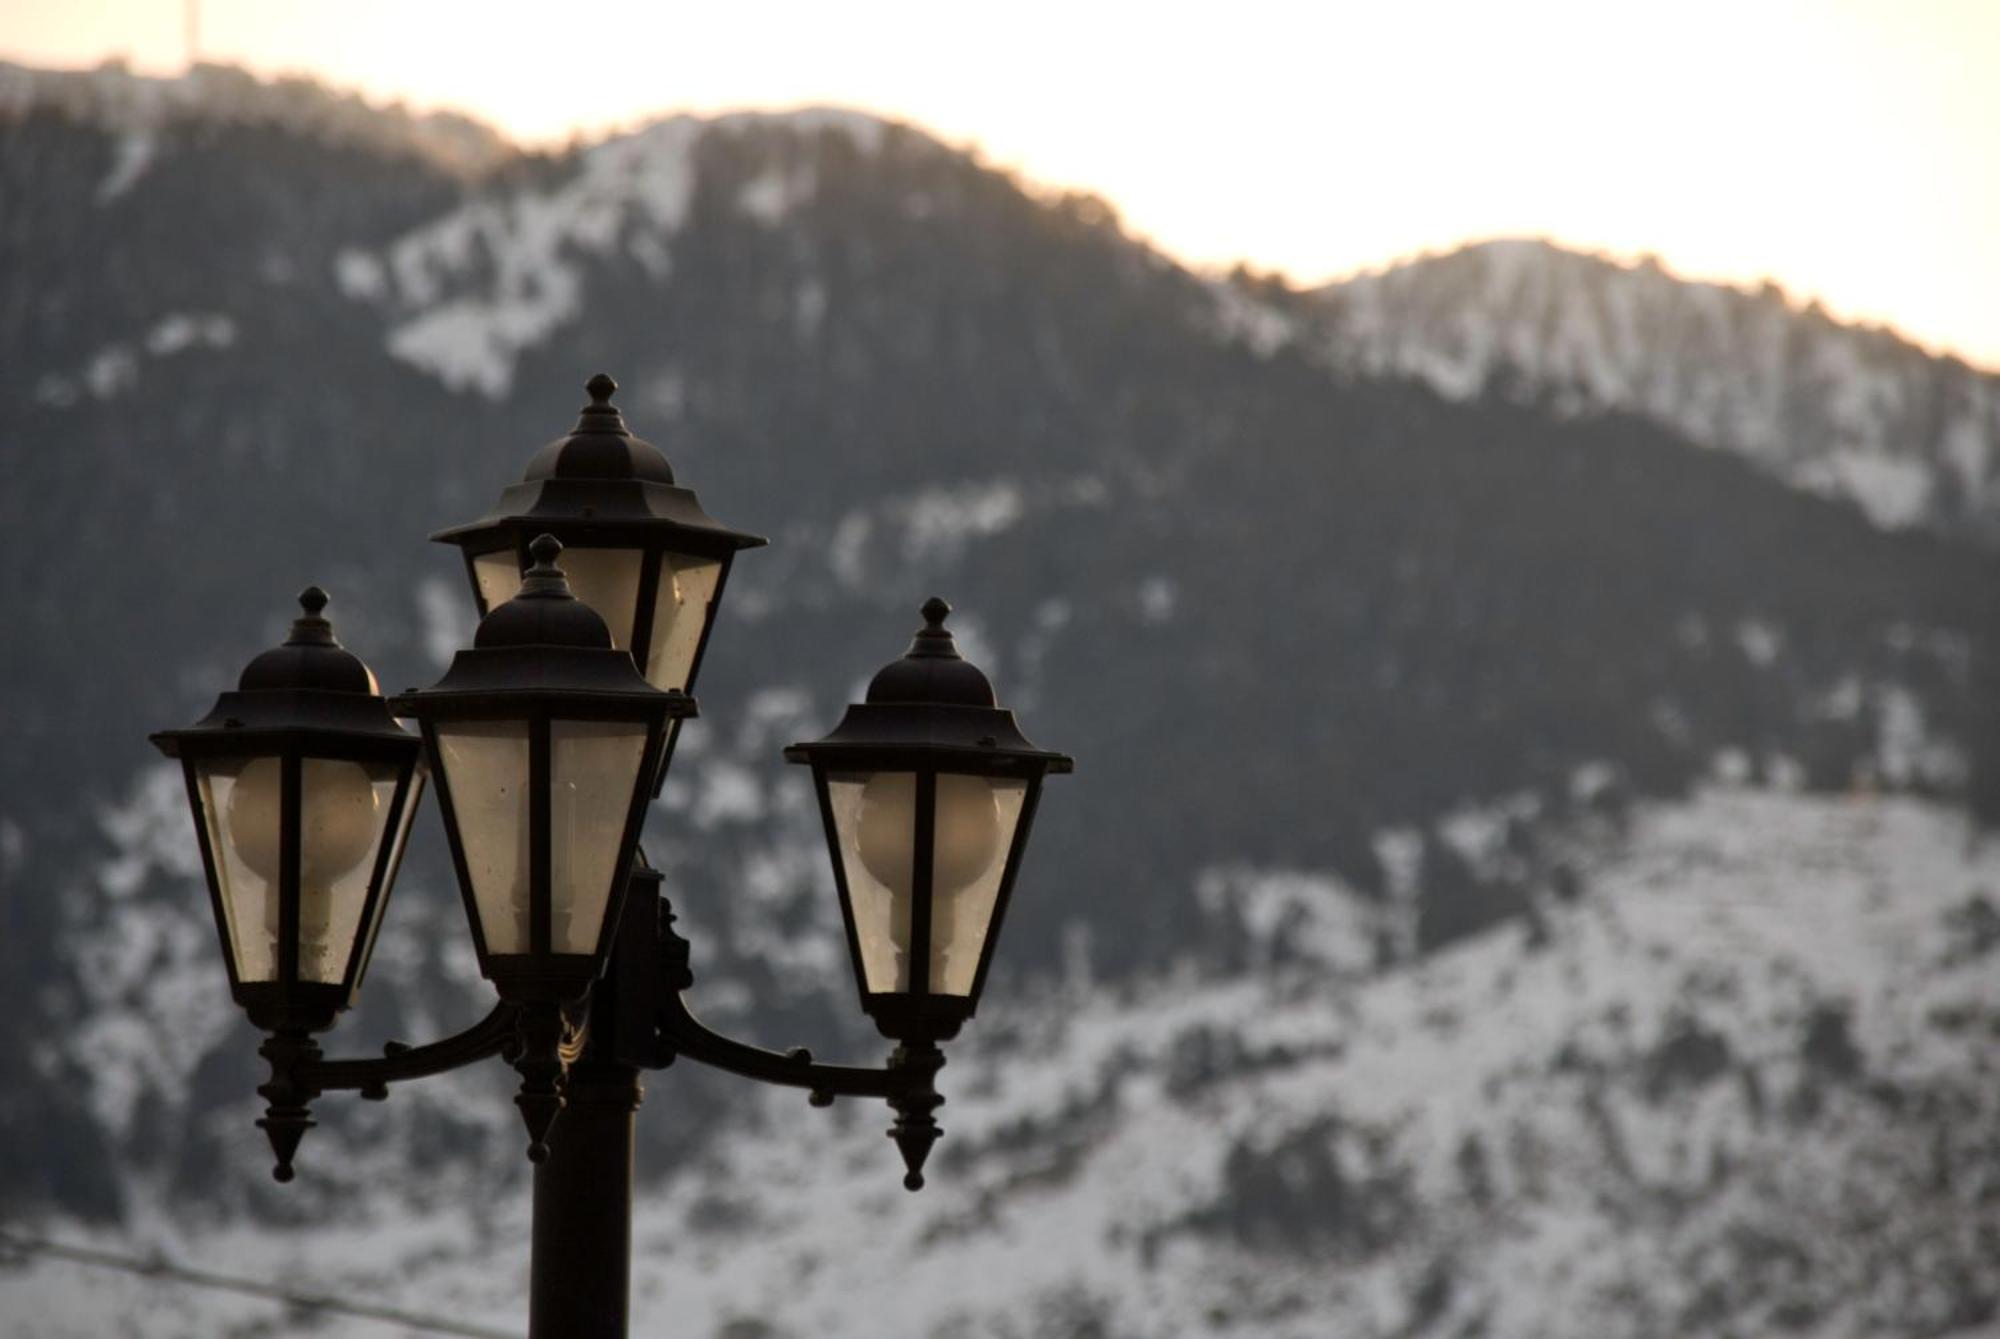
<box><xmin>786</xmin><ymin>600</ymin><xmax>1072</xmax><ymax>1043</ymax></box>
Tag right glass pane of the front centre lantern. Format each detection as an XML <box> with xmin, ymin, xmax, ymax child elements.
<box><xmin>548</xmin><ymin>721</ymin><xmax>646</xmax><ymax>953</ymax></box>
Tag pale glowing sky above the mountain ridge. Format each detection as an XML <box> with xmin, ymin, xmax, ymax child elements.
<box><xmin>11</xmin><ymin>0</ymin><xmax>2000</xmax><ymax>370</ymax></box>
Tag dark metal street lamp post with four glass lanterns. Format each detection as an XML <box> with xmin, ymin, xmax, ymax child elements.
<box><xmin>154</xmin><ymin>376</ymin><xmax>1070</xmax><ymax>1339</ymax></box>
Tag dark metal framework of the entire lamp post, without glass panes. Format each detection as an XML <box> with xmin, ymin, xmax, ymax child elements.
<box><xmin>154</xmin><ymin>374</ymin><xmax>1070</xmax><ymax>1339</ymax></box>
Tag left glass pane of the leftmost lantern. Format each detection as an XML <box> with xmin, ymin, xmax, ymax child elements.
<box><xmin>196</xmin><ymin>757</ymin><xmax>280</xmax><ymax>981</ymax></box>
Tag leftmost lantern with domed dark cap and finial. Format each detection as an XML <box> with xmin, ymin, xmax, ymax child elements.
<box><xmin>152</xmin><ymin>586</ymin><xmax>422</xmax><ymax>1035</ymax></box>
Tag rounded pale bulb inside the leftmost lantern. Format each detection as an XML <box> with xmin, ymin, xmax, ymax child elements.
<box><xmin>224</xmin><ymin>757</ymin><xmax>380</xmax><ymax>977</ymax></box>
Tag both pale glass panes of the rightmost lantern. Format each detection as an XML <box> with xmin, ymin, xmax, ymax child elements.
<box><xmin>826</xmin><ymin>771</ymin><xmax>1026</xmax><ymax>995</ymax></box>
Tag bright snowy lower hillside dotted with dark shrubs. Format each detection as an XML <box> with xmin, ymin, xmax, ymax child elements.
<box><xmin>15</xmin><ymin>783</ymin><xmax>2000</xmax><ymax>1339</ymax></box>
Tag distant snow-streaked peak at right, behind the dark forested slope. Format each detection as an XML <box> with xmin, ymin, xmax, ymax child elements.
<box><xmin>1222</xmin><ymin>240</ymin><xmax>2000</xmax><ymax>540</ymax></box>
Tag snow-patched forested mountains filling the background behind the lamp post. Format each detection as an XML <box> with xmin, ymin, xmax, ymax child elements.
<box><xmin>0</xmin><ymin>60</ymin><xmax>2000</xmax><ymax>1339</ymax></box>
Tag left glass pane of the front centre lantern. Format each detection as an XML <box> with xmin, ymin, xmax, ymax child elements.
<box><xmin>436</xmin><ymin>721</ymin><xmax>528</xmax><ymax>953</ymax></box>
